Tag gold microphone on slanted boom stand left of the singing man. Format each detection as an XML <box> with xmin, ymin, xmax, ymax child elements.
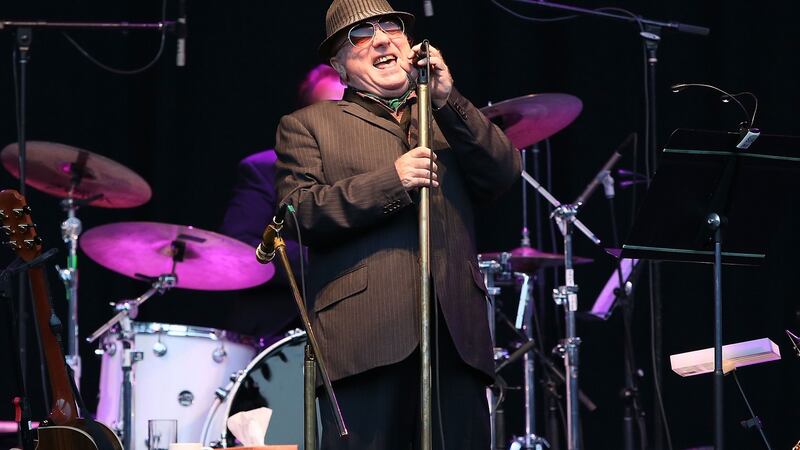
<box><xmin>256</xmin><ymin>206</ymin><xmax>347</xmax><ymax>450</ymax></box>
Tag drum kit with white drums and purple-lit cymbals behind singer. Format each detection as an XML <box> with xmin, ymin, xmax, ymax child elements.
<box><xmin>0</xmin><ymin>94</ymin><xmax>591</xmax><ymax>450</ymax></box>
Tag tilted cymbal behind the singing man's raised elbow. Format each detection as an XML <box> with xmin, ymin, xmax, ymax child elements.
<box><xmin>481</xmin><ymin>94</ymin><xmax>583</xmax><ymax>149</ymax></box>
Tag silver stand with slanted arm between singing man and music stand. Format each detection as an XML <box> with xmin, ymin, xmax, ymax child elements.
<box><xmin>522</xmin><ymin>171</ymin><xmax>600</xmax><ymax>450</ymax></box>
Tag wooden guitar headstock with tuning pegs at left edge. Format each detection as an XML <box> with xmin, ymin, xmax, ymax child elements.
<box><xmin>0</xmin><ymin>189</ymin><xmax>42</xmax><ymax>261</ymax></box>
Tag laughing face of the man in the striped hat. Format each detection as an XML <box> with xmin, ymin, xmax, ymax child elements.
<box><xmin>331</xmin><ymin>19</ymin><xmax>412</xmax><ymax>97</ymax></box>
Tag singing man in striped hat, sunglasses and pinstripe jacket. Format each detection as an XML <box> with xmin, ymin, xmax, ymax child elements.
<box><xmin>276</xmin><ymin>0</ymin><xmax>520</xmax><ymax>450</ymax></box>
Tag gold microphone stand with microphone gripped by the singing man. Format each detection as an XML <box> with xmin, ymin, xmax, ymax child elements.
<box><xmin>417</xmin><ymin>39</ymin><xmax>433</xmax><ymax>450</ymax></box>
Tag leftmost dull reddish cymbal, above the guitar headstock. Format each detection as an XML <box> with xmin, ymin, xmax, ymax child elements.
<box><xmin>0</xmin><ymin>141</ymin><xmax>152</xmax><ymax>208</ymax></box>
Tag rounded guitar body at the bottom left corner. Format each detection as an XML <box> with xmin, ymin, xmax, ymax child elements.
<box><xmin>36</xmin><ymin>419</ymin><xmax>123</xmax><ymax>450</ymax></box>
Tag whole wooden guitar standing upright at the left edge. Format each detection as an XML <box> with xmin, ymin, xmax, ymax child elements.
<box><xmin>0</xmin><ymin>190</ymin><xmax>123</xmax><ymax>450</ymax></box>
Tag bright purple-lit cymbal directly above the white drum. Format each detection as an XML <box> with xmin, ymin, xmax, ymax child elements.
<box><xmin>80</xmin><ymin>222</ymin><xmax>275</xmax><ymax>291</ymax></box>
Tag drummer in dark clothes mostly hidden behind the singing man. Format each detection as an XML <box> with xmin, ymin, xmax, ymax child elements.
<box><xmin>219</xmin><ymin>64</ymin><xmax>344</xmax><ymax>337</ymax></box>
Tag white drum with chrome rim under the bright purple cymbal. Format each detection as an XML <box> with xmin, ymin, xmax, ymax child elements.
<box><xmin>97</xmin><ymin>322</ymin><xmax>256</xmax><ymax>450</ymax></box>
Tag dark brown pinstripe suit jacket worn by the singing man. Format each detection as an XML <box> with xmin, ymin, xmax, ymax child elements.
<box><xmin>276</xmin><ymin>89</ymin><xmax>520</xmax><ymax>380</ymax></box>
